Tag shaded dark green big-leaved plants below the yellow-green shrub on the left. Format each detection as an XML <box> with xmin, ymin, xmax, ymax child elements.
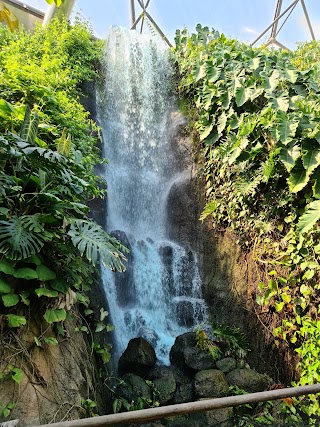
<box><xmin>0</xmin><ymin>104</ymin><xmax>125</xmax><ymax>332</ymax></box>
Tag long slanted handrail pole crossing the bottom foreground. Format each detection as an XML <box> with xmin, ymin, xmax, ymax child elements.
<box><xmin>40</xmin><ymin>384</ymin><xmax>320</xmax><ymax>427</ymax></box>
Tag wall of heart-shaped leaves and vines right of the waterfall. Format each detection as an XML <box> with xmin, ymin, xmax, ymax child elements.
<box><xmin>175</xmin><ymin>26</ymin><xmax>320</xmax><ymax>424</ymax></box>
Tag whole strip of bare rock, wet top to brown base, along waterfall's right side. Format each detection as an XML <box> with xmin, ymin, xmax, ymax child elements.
<box><xmin>168</xmin><ymin>113</ymin><xmax>296</xmax><ymax>383</ymax></box>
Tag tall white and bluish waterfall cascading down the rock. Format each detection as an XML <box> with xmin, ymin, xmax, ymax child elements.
<box><xmin>99</xmin><ymin>28</ymin><xmax>205</xmax><ymax>363</ymax></box>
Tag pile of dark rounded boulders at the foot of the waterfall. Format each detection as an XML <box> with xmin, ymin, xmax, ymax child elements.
<box><xmin>116</xmin><ymin>332</ymin><xmax>272</xmax><ymax>427</ymax></box>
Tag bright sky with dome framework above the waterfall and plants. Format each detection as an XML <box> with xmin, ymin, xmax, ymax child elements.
<box><xmin>11</xmin><ymin>0</ymin><xmax>320</xmax><ymax>50</ymax></box>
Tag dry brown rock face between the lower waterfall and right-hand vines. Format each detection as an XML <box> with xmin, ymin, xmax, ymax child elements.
<box><xmin>202</xmin><ymin>226</ymin><xmax>297</xmax><ymax>383</ymax></box>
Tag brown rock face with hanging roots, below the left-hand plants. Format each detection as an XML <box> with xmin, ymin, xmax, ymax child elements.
<box><xmin>0</xmin><ymin>313</ymin><xmax>104</xmax><ymax>426</ymax></box>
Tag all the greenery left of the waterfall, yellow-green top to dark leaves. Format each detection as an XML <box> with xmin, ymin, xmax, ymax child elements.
<box><xmin>0</xmin><ymin>21</ymin><xmax>125</xmax><ymax>415</ymax></box>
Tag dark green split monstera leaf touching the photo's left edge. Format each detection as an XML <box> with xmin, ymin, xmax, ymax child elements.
<box><xmin>0</xmin><ymin>215</ymin><xmax>50</xmax><ymax>260</ymax></box>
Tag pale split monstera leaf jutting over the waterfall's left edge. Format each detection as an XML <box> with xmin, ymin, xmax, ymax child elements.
<box><xmin>68</xmin><ymin>220</ymin><xmax>127</xmax><ymax>271</ymax></box>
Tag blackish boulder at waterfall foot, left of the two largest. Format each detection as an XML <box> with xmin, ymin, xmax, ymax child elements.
<box><xmin>118</xmin><ymin>338</ymin><xmax>157</xmax><ymax>377</ymax></box>
